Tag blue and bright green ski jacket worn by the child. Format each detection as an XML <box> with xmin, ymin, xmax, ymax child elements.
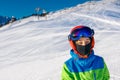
<box><xmin>62</xmin><ymin>50</ymin><xmax>110</xmax><ymax>80</ymax></box>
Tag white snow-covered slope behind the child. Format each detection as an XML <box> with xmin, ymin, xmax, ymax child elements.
<box><xmin>0</xmin><ymin>0</ymin><xmax>120</xmax><ymax>80</ymax></box>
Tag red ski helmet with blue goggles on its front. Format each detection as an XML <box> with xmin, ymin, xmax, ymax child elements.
<box><xmin>68</xmin><ymin>26</ymin><xmax>95</xmax><ymax>54</ymax></box>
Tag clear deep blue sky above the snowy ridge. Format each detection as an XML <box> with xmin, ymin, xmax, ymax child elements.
<box><xmin>0</xmin><ymin>0</ymin><xmax>90</xmax><ymax>18</ymax></box>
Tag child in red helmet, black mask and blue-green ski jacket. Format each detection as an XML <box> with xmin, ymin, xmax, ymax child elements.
<box><xmin>62</xmin><ymin>26</ymin><xmax>110</xmax><ymax>80</ymax></box>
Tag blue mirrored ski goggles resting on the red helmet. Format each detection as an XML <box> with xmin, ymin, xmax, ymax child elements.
<box><xmin>68</xmin><ymin>27</ymin><xmax>94</xmax><ymax>41</ymax></box>
